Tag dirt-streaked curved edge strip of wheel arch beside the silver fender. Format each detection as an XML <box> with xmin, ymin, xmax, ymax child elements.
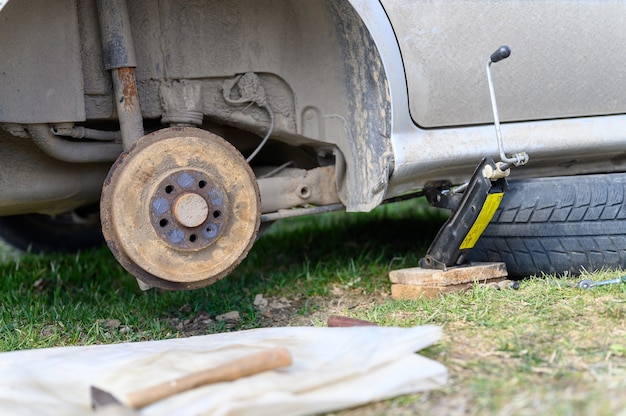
<box><xmin>320</xmin><ymin>1</ymin><xmax>393</xmax><ymax>211</ymax></box>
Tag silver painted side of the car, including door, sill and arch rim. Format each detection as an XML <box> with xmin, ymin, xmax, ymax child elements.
<box><xmin>355</xmin><ymin>1</ymin><xmax>626</xmax><ymax>197</ymax></box>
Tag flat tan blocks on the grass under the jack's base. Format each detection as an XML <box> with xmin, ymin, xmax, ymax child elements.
<box><xmin>389</xmin><ymin>263</ymin><xmax>508</xmax><ymax>299</ymax></box>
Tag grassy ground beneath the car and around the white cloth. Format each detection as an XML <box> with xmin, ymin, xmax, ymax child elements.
<box><xmin>0</xmin><ymin>201</ymin><xmax>626</xmax><ymax>416</ymax></box>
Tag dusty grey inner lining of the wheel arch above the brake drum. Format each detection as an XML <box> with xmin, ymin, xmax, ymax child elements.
<box><xmin>129</xmin><ymin>0</ymin><xmax>393</xmax><ymax>211</ymax></box>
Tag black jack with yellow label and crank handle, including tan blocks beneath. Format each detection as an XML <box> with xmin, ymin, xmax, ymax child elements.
<box><xmin>389</xmin><ymin>46</ymin><xmax>528</xmax><ymax>299</ymax></box>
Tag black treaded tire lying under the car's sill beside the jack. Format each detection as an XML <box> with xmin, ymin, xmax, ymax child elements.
<box><xmin>470</xmin><ymin>173</ymin><xmax>626</xmax><ymax>276</ymax></box>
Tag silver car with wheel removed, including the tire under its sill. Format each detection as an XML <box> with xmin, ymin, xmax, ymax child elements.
<box><xmin>0</xmin><ymin>0</ymin><xmax>626</xmax><ymax>290</ymax></box>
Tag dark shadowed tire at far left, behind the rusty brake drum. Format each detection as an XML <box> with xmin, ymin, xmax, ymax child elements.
<box><xmin>0</xmin><ymin>205</ymin><xmax>104</xmax><ymax>254</ymax></box>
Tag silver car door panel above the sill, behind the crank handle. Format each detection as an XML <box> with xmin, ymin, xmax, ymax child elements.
<box><xmin>381</xmin><ymin>0</ymin><xmax>626</xmax><ymax>128</ymax></box>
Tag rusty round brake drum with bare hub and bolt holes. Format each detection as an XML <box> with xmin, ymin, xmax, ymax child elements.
<box><xmin>100</xmin><ymin>127</ymin><xmax>261</xmax><ymax>290</ymax></box>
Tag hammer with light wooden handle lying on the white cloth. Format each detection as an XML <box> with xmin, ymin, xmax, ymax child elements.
<box><xmin>91</xmin><ymin>348</ymin><xmax>292</xmax><ymax>410</ymax></box>
